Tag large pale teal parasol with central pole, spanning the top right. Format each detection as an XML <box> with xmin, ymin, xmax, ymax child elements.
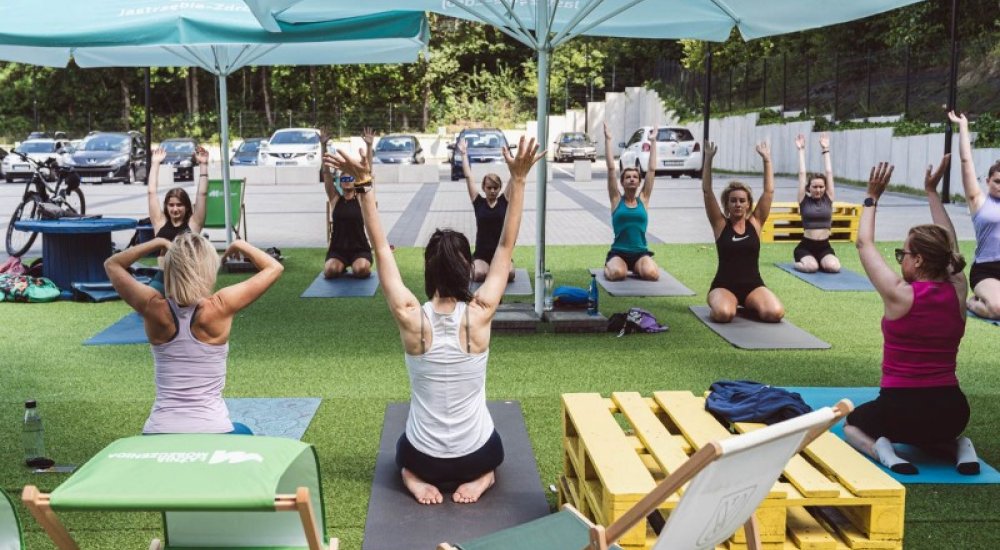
<box><xmin>244</xmin><ymin>0</ymin><xmax>920</xmax><ymax>315</ymax></box>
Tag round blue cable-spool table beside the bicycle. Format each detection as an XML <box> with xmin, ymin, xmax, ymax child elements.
<box><xmin>14</xmin><ymin>218</ymin><xmax>136</xmax><ymax>289</ymax></box>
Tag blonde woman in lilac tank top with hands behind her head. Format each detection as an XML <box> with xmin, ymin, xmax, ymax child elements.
<box><xmin>104</xmin><ymin>232</ymin><xmax>284</xmax><ymax>434</ymax></box>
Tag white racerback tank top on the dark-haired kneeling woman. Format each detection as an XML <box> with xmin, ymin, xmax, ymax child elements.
<box><xmin>406</xmin><ymin>302</ymin><xmax>493</xmax><ymax>458</ymax></box>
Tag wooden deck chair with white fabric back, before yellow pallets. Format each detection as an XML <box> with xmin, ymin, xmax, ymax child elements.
<box><xmin>438</xmin><ymin>399</ymin><xmax>853</xmax><ymax>550</ymax></box>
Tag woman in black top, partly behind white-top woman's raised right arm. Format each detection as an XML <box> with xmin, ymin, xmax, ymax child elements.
<box><xmin>457</xmin><ymin>139</ymin><xmax>514</xmax><ymax>283</ymax></box>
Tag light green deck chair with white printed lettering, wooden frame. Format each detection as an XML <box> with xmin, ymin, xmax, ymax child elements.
<box><xmin>21</xmin><ymin>434</ymin><xmax>337</xmax><ymax>550</ymax></box>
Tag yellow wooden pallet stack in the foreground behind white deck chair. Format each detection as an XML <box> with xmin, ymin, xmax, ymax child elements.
<box><xmin>559</xmin><ymin>391</ymin><xmax>905</xmax><ymax>550</ymax></box>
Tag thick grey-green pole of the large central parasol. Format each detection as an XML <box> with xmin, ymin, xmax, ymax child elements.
<box><xmin>535</xmin><ymin>2</ymin><xmax>552</xmax><ymax>318</ymax></box>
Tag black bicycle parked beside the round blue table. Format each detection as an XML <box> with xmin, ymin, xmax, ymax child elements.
<box><xmin>0</xmin><ymin>149</ymin><xmax>87</xmax><ymax>256</ymax></box>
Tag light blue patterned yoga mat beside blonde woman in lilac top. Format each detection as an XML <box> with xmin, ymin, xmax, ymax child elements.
<box><xmin>226</xmin><ymin>397</ymin><xmax>322</xmax><ymax>439</ymax></box>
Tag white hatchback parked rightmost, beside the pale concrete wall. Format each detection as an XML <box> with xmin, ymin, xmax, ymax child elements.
<box><xmin>618</xmin><ymin>126</ymin><xmax>701</xmax><ymax>178</ymax></box>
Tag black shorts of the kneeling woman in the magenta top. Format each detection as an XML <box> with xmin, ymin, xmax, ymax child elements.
<box><xmin>847</xmin><ymin>386</ymin><xmax>969</xmax><ymax>446</ymax></box>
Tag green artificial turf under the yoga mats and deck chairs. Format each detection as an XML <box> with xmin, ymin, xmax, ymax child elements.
<box><xmin>0</xmin><ymin>243</ymin><xmax>1000</xmax><ymax>550</ymax></box>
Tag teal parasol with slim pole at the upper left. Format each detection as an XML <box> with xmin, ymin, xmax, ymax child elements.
<box><xmin>0</xmin><ymin>0</ymin><xmax>429</xmax><ymax>243</ymax></box>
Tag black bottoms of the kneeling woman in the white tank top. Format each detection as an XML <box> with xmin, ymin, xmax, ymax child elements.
<box><xmin>396</xmin><ymin>430</ymin><xmax>503</xmax><ymax>485</ymax></box>
